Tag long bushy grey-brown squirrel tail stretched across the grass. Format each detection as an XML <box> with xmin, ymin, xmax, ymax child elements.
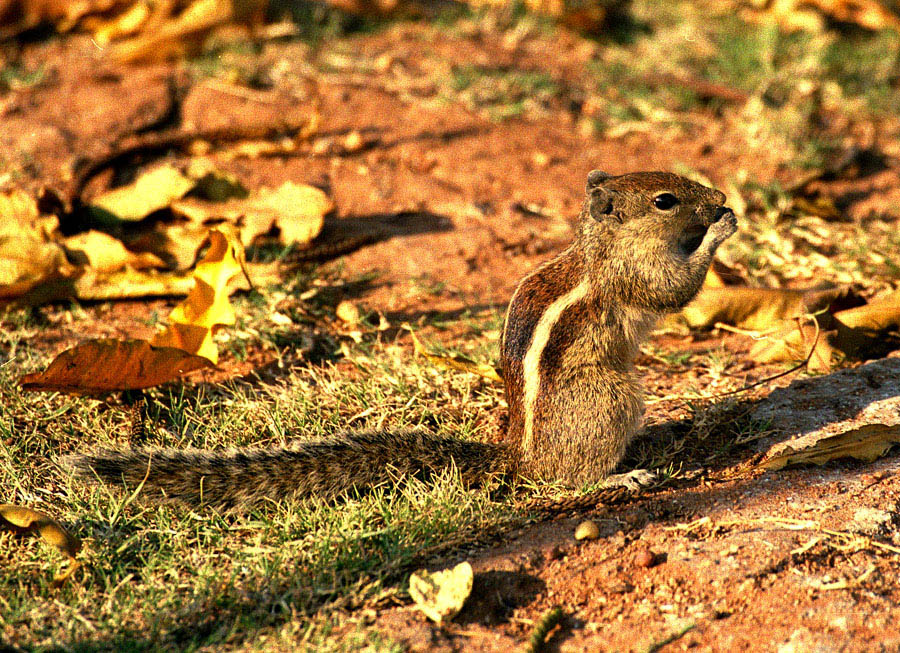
<box><xmin>69</xmin><ymin>432</ymin><xmax>513</xmax><ymax>511</ymax></box>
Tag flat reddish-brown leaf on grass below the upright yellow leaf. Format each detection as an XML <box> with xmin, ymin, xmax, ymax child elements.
<box><xmin>19</xmin><ymin>339</ymin><xmax>213</xmax><ymax>395</ymax></box>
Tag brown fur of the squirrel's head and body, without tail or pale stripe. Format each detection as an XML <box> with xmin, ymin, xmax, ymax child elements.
<box><xmin>501</xmin><ymin>172</ymin><xmax>736</xmax><ymax>484</ymax></box>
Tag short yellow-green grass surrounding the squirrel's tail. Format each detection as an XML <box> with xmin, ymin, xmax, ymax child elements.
<box><xmin>0</xmin><ymin>284</ymin><xmax>511</xmax><ymax>651</ymax></box>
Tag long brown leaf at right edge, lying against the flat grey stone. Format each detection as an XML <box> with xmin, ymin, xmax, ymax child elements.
<box><xmin>760</xmin><ymin>424</ymin><xmax>900</xmax><ymax>470</ymax></box>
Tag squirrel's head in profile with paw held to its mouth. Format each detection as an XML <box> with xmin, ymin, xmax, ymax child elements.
<box><xmin>578</xmin><ymin>170</ymin><xmax>735</xmax><ymax>311</ymax></box>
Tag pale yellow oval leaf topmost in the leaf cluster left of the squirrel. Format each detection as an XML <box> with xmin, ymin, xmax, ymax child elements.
<box><xmin>91</xmin><ymin>164</ymin><xmax>196</xmax><ymax>221</ymax></box>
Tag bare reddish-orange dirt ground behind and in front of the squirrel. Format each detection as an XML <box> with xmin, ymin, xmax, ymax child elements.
<box><xmin>0</xmin><ymin>25</ymin><xmax>900</xmax><ymax>653</ymax></box>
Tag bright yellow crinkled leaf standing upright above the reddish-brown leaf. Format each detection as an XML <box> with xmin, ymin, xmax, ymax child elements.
<box><xmin>151</xmin><ymin>225</ymin><xmax>244</xmax><ymax>363</ymax></box>
